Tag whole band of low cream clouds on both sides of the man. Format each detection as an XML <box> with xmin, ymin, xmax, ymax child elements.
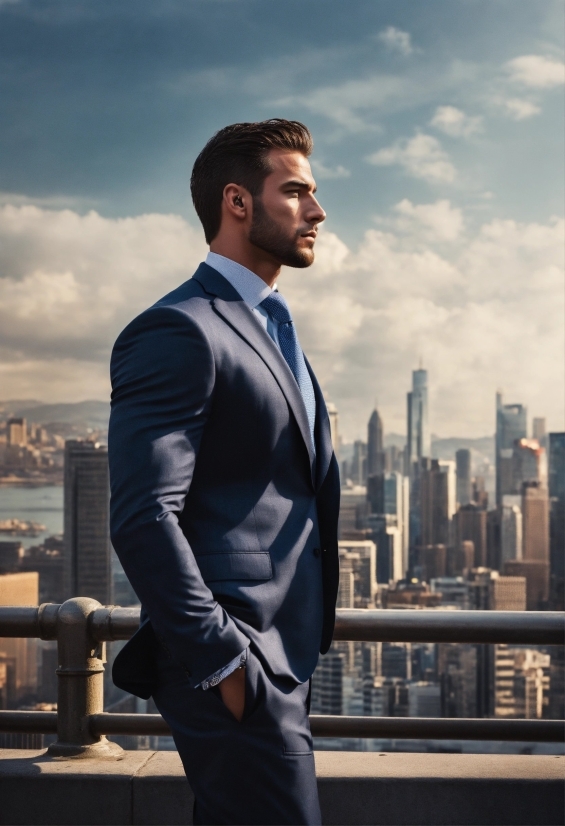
<box><xmin>0</xmin><ymin>199</ymin><xmax>565</xmax><ymax>438</ymax></box>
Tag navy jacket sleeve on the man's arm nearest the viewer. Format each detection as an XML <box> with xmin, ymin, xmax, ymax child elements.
<box><xmin>108</xmin><ymin>306</ymin><xmax>249</xmax><ymax>686</ymax></box>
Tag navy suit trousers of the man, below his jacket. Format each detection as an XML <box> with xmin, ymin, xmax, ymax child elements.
<box><xmin>153</xmin><ymin>647</ymin><xmax>322</xmax><ymax>826</ymax></box>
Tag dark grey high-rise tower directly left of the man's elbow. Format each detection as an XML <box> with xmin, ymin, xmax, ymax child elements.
<box><xmin>63</xmin><ymin>440</ymin><xmax>112</xmax><ymax>605</ymax></box>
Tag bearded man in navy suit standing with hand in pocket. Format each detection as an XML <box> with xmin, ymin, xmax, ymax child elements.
<box><xmin>109</xmin><ymin>119</ymin><xmax>339</xmax><ymax>824</ymax></box>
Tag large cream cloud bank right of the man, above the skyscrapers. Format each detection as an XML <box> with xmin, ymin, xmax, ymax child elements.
<box><xmin>279</xmin><ymin>214</ymin><xmax>565</xmax><ymax>439</ymax></box>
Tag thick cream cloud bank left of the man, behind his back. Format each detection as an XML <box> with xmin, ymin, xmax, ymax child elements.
<box><xmin>0</xmin><ymin>206</ymin><xmax>206</xmax><ymax>376</ymax></box>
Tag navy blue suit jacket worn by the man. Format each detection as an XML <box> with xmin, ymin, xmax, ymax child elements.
<box><xmin>108</xmin><ymin>264</ymin><xmax>339</xmax><ymax>697</ymax></box>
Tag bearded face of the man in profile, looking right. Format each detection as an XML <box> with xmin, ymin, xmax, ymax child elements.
<box><xmin>249</xmin><ymin>149</ymin><xmax>326</xmax><ymax>267</ymax></box>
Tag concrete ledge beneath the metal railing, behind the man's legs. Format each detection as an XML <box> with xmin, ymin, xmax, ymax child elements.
<box><xmin>0</xmin><ymin>749</ymin><xmax>565</xmax><ymax>826</ymax></box>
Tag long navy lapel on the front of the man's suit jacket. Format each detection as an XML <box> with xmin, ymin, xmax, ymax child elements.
<box><xmin>193</xmin><ymin>264</ymin><xmax>318</xmax><ymax>482</ymax></box>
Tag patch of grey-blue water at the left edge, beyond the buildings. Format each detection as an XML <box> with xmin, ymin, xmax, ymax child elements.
<box><xmin>0</xmin><ymin>485</ymin><xmax>63</xmax><ymax>548</ymax></box>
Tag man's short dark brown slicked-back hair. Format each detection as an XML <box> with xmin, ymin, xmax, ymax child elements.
<box><xmin>190</xmin><ymin>118</ymin><xmax>314</xmax><ymax>243</ymax></box>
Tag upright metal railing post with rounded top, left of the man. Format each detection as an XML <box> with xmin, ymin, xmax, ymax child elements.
<box><xmin>48</xmin><ymin>597</ymin><xmax>123</xmax><ymax>759</ymax></box>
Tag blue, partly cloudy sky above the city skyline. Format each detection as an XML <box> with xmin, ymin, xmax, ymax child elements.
<box><xmin>0</xmin><ymin>0</ymin><xmax>565</xmax><ymax>439</ymax></box>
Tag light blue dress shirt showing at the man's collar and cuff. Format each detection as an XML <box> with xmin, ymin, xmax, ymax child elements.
<box><xmin>197</xmin><ymin>252</ymin><xmax>315</xmax><ymax>691</ymax></box>
